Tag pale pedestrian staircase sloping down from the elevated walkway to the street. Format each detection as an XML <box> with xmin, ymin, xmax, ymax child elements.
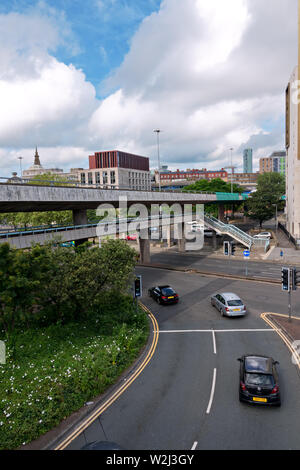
<box><xmin>204</xmin><ymin>214</ymin><xmax>270</xmax><ymax>251</ymax></box>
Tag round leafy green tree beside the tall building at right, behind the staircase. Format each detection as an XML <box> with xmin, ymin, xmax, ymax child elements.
<box><xmin>247</xmin><ymin>173</ymin><xmax>285</xmax><ymax>228</ymax></box>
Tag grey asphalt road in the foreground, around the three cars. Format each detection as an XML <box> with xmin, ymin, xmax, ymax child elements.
<box><xmin>68</xmin><ymin>267</ymin><xmax>300</xmax><ymax>450</ymax></box>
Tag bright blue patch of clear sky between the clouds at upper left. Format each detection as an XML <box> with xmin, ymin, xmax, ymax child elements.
<box><xmin>0</xmin><ymin>0</ymin><xmax>161</xmax><ymax>95</ymax></box>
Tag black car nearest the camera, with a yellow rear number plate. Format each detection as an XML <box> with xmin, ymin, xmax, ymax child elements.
<box><xmin>238</xmin><ymin>355</ymin><xmax>281</xmax><ymax>406</ymax></box>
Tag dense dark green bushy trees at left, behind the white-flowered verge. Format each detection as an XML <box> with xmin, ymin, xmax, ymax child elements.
<box><xmin>0</xmin><ymin>240</ymin><xmax>137</xmax><ymax>338</ymax></box>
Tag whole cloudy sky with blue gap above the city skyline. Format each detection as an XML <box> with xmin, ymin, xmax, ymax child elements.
<box><xmin>0</xmin><ymin>0</ymin><xmax>297</xmax><ymax>176</ymax></box>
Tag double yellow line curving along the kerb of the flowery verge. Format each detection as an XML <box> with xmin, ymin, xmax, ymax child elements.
<box><xmin>54</xmin><ymin>304</ymin><xmax>159</xmax><ymax>450</ymax></box>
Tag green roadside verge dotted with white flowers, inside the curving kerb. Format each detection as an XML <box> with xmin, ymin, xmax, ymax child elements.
<box><xmin>0</xmin><ymin>301</ymin><xmax>149</xmax><ymax>450</ymax></box>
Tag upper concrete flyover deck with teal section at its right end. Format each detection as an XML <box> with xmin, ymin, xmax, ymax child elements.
<box><xmin>0</xmin><ymin>183</ymin><xmax>245</xmax><ymax>213</ymax></box>
